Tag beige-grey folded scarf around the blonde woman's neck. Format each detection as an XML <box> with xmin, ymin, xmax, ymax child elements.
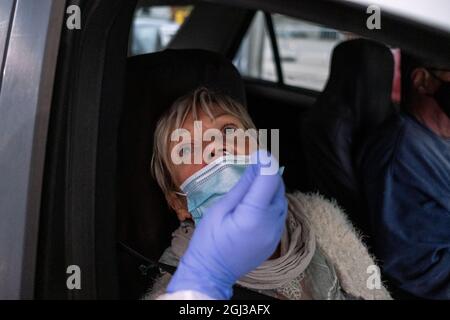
<box><xmin>167</xmin><ymin>194</ymin><xmax>316</xmax><ymax>290</ymax></box>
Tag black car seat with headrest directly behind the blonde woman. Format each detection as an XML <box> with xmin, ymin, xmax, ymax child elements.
<box><xmin>118</xmin><ymin>49</ymin><xmax>246</xmax><ymax>259</ymax></box>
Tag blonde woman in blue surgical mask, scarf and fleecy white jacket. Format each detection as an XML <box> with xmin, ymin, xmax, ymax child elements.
<box><xmin>144</xmin><ymin>88</ymin><xmax>390</xmax><ymax>300</ymax></box>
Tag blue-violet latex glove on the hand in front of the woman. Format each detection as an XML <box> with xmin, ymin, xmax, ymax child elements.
<box><xmin>167</xmin><ymin>151</ymin><xmax>287</xmax><ymax>299</ymax></box>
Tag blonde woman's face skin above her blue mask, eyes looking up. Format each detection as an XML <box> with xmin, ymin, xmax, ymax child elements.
<box><xmin>167</xmin><ymin>109</ymin><xmax>252</xmax><ymax>221</ymax></box>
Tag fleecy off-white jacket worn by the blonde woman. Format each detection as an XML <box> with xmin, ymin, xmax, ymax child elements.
<box><xmin>144</xmin><ymin>192</ymin><xmax>391</xmax><ymax>300</ymax></box>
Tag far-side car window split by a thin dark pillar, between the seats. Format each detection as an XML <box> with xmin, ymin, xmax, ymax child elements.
<box><xmin>234</xmin><ymin>12</ymin><xmax>356</xmax><ymax>91</ymax></box>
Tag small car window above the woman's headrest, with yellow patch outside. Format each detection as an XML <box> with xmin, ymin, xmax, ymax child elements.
<box><xmin>128</xmin><ymin>5</ymin><xmax>193</xmax><ymax>56</ymax></box>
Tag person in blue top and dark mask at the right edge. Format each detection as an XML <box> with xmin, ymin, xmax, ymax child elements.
<box><xmin>361</xmin><ymin>55</ymin><xmax>450</xmax><ymax>299</ymax></box>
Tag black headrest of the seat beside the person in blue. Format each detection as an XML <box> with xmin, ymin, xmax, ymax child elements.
<box><xmin>314</xmin><ymin>39</ymin><xmax>394</xmax><ymax>135</ymax></box>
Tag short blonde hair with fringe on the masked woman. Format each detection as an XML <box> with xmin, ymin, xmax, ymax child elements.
<box><xmin>151</xmin><ymin>87</ymin><xmax>256</xmax><ymax>195</ymax></box>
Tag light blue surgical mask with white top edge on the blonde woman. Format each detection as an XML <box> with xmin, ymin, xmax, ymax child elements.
<box><xmin>180</xmin><ymin>155</ymin><xmax>250</xmax><ymax>225</ymax></box>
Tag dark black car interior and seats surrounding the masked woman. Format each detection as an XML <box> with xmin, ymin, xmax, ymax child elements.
<box><xmin>35</xmin><ymin>0</ymin><xmax>450</xmax><ymax>299</ymax></box>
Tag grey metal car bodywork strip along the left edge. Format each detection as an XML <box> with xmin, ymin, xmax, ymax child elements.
<box><xmin>0</xmin><ymin>0</ymin><xmax>64</xmax><ymax>299</ymax></box>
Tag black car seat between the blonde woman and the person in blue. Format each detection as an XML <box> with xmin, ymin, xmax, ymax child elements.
<box><xmin>302</xmin><ymin>39</ymin><xmax>395</xmax><ymax>236</ymax></box>
